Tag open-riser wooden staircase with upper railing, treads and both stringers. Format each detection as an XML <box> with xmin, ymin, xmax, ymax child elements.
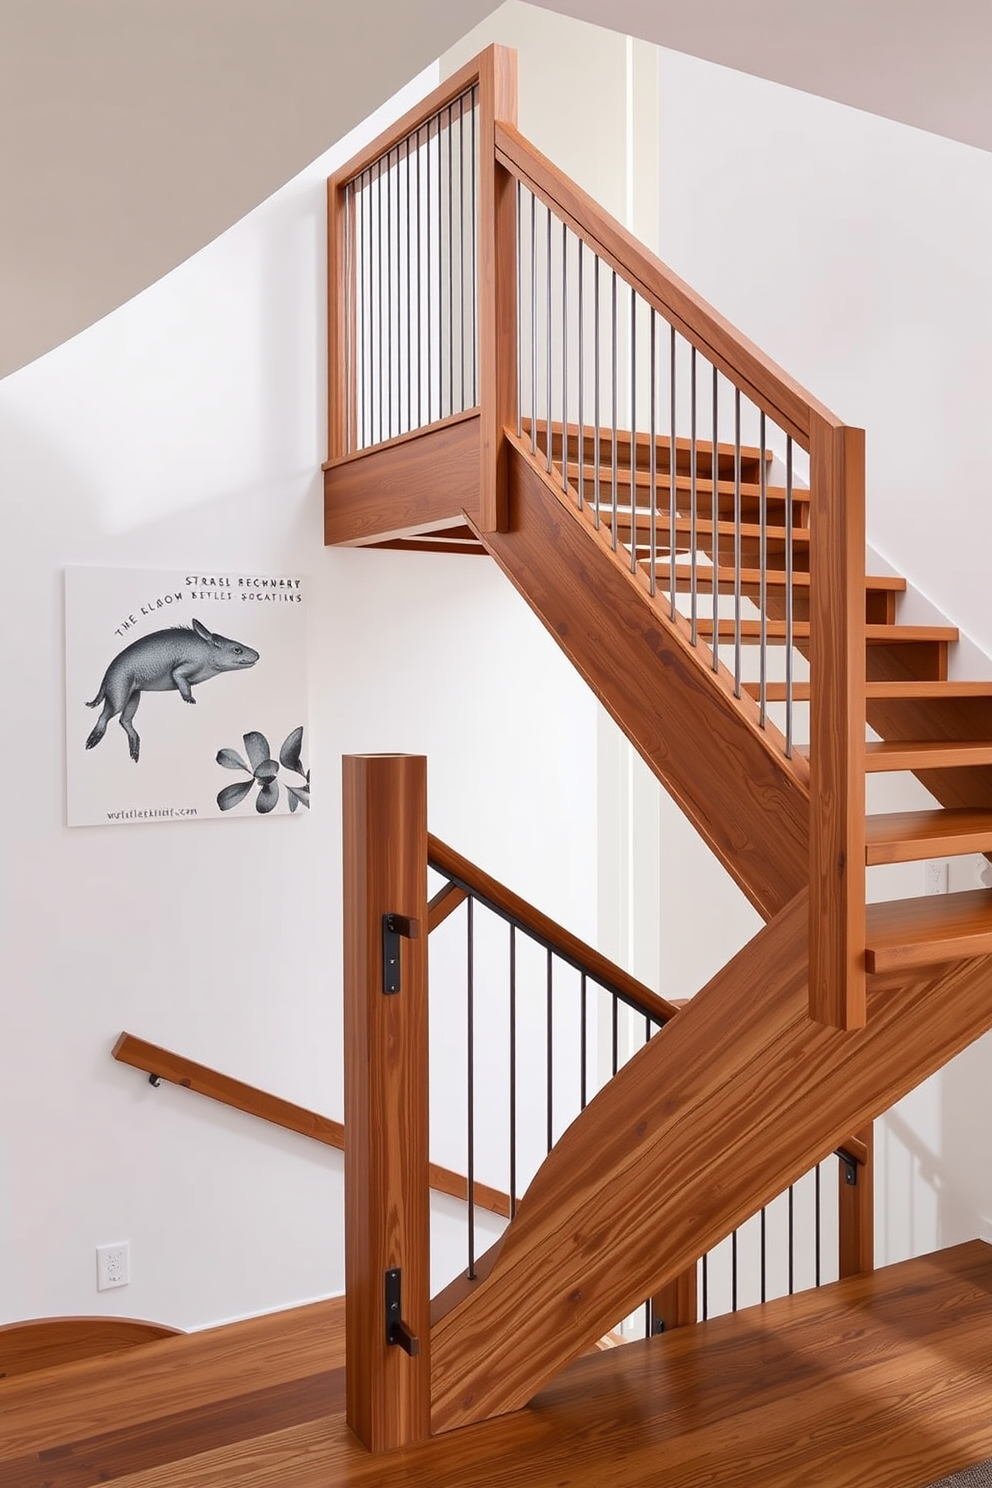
<box><xmin>326</xmin><ymin>49</ymin><xmax>992</xmax><ymax>1439</ymax></box>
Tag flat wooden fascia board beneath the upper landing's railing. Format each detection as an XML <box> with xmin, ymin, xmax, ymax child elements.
<box><xmin>324</xmin><ymin>409</ymin><xmax>479</xmax><ymax>546</ymax></box>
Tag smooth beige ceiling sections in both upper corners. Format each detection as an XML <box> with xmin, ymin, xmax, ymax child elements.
<box><xmin>0</xmin><ymin>0</ymin><xmax>992</xmax><ymax>376</ymax></box>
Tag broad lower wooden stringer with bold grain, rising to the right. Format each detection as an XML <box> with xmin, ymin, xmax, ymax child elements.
<box><xmin>431</xmin><ymin>893</ymin><xmax>992</xmax><ymax>1430</ymax></box>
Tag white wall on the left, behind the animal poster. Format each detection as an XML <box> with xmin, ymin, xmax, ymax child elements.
<box><xmin>0</xmin><ymin>63</ymin><xmax>595</xmax><ymax>1327</ymax></box>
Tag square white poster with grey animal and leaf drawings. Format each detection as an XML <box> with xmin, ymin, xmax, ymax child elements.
<box><xmin>65</xmin><ymin>568</ymin><xmax>309</xmax><ymax>826</ymax></box>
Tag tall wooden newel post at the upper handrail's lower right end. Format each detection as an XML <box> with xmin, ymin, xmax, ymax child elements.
<box><xmin>809</xmin><ymin>412</ymin><xmax>866</xmax><ymax>1028</ymax></box>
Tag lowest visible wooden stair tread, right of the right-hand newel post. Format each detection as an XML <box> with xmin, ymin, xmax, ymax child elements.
<box><xmin>866</xmin><ymin>888</ymin><xmax>992</xmax><ymax>973</ymax></box>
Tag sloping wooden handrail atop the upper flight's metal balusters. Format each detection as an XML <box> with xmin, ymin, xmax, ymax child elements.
<box><xmin>497</xmin><ymin>125</ymin><xmax>833</xmax><ymax>448</ymax></box>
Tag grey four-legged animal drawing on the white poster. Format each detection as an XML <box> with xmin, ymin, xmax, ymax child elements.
<box><xmin>86</xmin><ymin>619</ymin><xmax>259</xmax><ymax>763</ymax></box>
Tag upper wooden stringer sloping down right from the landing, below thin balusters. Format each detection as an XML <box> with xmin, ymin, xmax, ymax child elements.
<box><xmin>483</xmin><ymin>434</ymin><xmax>809</xmax><ymax>917</ymax></box>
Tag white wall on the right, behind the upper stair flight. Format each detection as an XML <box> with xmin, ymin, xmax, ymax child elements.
<box><xmin>659</xmin><ymin>51</ymin><xmax>992</xmax><ymax>1260</ymax></box>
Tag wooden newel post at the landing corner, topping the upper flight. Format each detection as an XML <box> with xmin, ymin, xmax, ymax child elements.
<box><xmin>477</xmin><ymin>46</ymin><xmax>516</xmax><ymax>533</ymax></box>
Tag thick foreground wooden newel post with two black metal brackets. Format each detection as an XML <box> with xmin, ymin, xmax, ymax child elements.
<box><xmin>344</xmin><ymin>754</ymin><xmax>430</xmax><ymax>1452</ymax></box>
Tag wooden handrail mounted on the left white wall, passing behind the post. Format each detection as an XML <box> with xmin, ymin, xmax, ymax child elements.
<box><xmin>112</xmin><ymin>1033</ymin><xmax>510</xmax><ymax>1219</ymax></box>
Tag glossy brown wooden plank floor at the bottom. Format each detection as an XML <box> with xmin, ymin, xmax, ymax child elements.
<box><xmin>0</xmin><ymin>1241</ymin><xmax>992</xmax><ymax>1488</ymax></box>
